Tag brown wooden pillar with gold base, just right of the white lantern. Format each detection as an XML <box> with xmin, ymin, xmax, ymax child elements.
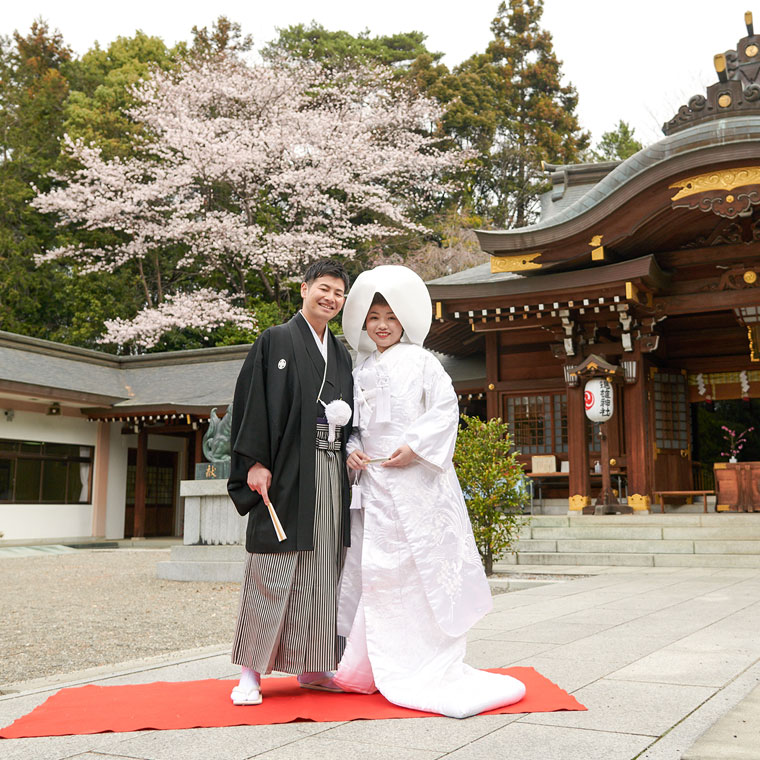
<box><xmin>623</xmin><ymin>353</ymin><xmax>653</xmax><ymax>513</ymax></box>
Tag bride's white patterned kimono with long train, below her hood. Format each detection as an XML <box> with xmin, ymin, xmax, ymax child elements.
<box><xmin>335</xmin><ymin>343</ymin><xmax>525</xmax><ymax>718</ymax></box>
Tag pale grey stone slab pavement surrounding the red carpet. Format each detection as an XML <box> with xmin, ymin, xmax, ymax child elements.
<box><xmin>0</xmin><ymin>566</ymin><xmax>760</xmax><ymax>760</ymax></box>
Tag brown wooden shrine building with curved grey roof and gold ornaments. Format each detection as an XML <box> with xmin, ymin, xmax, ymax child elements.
<box><xmin>427</xmin><ymin>14</ymin><xmax>760</xmax><ymax>513</ymax></box>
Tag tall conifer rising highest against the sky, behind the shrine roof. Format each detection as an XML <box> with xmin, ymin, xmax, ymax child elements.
<box><xmin>412</xmin><ymin>0</ymin><xmax>589</xmax><ymax>227</ymax></box>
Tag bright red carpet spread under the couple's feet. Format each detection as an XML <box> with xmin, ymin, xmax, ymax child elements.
<box><xmin>0</xmin><ymin>668</ymin><xmax>586</xmax><ymax>739</ymax></box>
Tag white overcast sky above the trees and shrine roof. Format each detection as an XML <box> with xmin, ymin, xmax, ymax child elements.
<box><xmin>0</xmin><ymin>0</ymin><xmax>760</xmax><ymax>143</ymax></box>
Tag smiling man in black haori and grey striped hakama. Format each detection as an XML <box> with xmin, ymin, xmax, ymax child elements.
<box><xmin>227</xmin><ymin>260</ymin><xmax>353</xmax><ymax>705</ymax></box>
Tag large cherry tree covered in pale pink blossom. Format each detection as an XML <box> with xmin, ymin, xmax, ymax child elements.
<box><xmin>33</xmin><ymin>56</ymin><xmax>468</xmax><ymax>348</ymax></box>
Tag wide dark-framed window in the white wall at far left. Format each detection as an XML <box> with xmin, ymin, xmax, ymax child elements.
<box><xmin>0</xmin><ymin>439</ymin><xmax>94</xmax><ymax>504</ymax></box>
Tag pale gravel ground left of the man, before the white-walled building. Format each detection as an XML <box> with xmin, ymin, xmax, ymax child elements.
<box><xmin>0</xmin><ymin>549</ymin><xmax>240</xmax><ymax>690</ymax></box>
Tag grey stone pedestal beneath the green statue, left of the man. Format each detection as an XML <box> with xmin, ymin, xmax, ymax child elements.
<box><xmin>158</xmin><ymin>480</ymin><xmax>248</xmax><ymax>582</ymax></box>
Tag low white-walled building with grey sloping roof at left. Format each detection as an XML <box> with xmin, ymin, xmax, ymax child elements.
<box><xmin>0</xmin><ymin>332</ymin><xmax>250</xmax><ymax>542</ymax></box>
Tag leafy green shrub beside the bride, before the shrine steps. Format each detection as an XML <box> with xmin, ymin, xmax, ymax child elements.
<box><xmin>454</xmin><ymin>415</ymin><xmax>529</xmax><ymax>575</ymax></box>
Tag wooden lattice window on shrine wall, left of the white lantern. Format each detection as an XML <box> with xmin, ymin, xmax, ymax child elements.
<box><xmin>504</xmin><ymin>393</ymin><xmax>567</xmax><ymax>454</ymax></box>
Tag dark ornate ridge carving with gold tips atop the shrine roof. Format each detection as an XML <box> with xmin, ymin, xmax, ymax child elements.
<box><xmin>662</xmin><ymin>12</ymin><xmax>760</xmax><ymax>135</ymax></box>
